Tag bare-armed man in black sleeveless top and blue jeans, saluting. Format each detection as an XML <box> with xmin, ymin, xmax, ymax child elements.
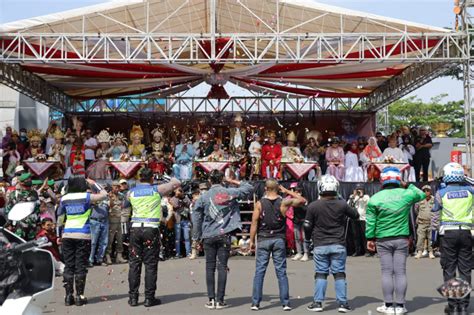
<box><xmin>250</xmin><ymin>179</ymin><xmax>306</xmax><ymax>311</ymax></box>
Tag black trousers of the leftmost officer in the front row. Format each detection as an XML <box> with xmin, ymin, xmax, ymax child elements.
<box><xmin>62</xmin><ymin>238</ymin><xmax>91</xmax><ymax>279</ymax></box>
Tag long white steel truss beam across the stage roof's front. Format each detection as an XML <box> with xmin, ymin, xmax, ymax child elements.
<box><xmin>0</xmin><ymin>32</ymin><xmax>469</xmax><ymax>65</ymax></box>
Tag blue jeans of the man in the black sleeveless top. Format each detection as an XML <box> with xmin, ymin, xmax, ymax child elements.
<box><xmin>252</xmin><ymin>238</ymin><xmax>290</xmax><ymax>305</ymax></box>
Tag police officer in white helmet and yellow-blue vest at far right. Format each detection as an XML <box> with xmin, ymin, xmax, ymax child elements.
<box><xmin>433</xmin><ymin>163</ymin><xmax>474</xmax><ymax>315</ymax></box>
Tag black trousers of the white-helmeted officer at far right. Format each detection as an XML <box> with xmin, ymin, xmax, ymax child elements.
<box><xmin>440</xmin><ymin>230</ymin><xmax>472</xmax><ymax>307</ymax></box>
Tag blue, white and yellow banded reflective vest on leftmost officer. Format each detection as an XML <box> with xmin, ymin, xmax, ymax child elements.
<box><xmin>61</xmin><ymin>193</ymin><xmax>92</xmax><ymax>238</ymax></box>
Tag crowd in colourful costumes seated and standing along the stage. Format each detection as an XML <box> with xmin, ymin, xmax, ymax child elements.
<box><xmin>1</xmin><ymin>115</ymin><xmax>432</xmax><ymax>182</ymax></box>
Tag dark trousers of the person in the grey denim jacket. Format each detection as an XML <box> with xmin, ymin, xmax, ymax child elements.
<box><xmin>203</xmin><ymin>235</ymin><xmax>231</xmax><ymax>302</ymax></box>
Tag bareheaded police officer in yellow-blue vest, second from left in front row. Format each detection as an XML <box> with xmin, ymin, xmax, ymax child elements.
<box><xmin>124</xmin><ymin>168</ymin><xmax>181</xmax><ymax>307</ymax></box>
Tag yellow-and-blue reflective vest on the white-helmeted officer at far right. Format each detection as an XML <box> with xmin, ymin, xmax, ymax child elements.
<box><xmin>441</xmin><ymin>187</ymin><xmax>473</xmax><ymax>229</ymax></box>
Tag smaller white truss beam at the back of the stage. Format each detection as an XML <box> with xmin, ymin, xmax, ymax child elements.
<box><xmin>68</xmin><ymin>96</ymin><xmax>362</xmax><ymax>115</ymax></box>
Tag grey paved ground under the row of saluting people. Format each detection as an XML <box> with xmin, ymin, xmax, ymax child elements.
<box><xmin>46</xmin><ymin>257</ymin><xmax>470</xmax><ymax>315</ymax></box>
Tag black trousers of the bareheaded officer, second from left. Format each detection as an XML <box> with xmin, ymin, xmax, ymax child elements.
<box><xmin>128</xmin><ymin>227</ymin><xmax>160</xmax><ymax>298</ymax></box>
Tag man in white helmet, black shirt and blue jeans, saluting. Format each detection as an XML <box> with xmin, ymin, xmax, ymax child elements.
<box><xmin>304</xmin><ymin>175</ymin><xmax>359</xmax><ymax>313</ymax></box>
